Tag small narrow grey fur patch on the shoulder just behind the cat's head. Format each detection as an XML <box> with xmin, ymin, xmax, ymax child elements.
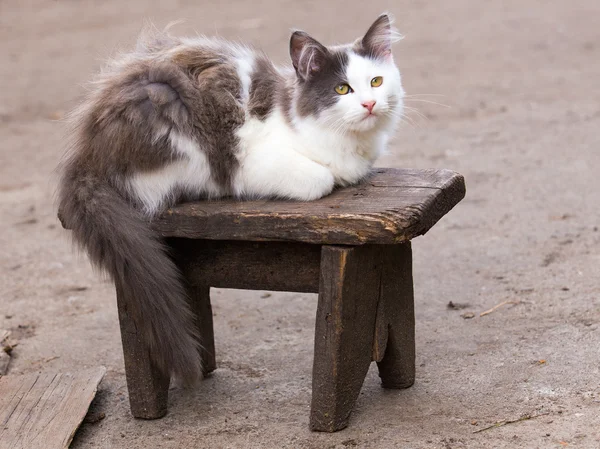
<box><xmin>248</xmin><ymin>55</ymin><xmax>280</xmax><ymax>120</ymax></box>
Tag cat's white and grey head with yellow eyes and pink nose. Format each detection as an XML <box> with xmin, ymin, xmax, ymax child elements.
<box><xmin>290</xmin><ymin>14</ymin><xmax>404</xmax><ymax>132</ymax></box>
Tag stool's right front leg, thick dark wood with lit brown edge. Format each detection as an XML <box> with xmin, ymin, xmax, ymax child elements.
<box><xmin>310</xmin><ymin>246</ymin><xmax>381</xmax><ymax>432</ymax></box>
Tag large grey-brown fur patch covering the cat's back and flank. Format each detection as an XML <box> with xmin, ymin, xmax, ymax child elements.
<box><xmin>76</xmin><ymin>43</ymin><xmax>244</xmax><ymax>191</ymax></box>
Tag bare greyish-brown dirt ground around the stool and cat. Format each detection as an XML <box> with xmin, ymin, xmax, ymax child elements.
<box><xmin>0</xmin><ymin>0</ymin><xmax>600</xmax><ymax>449</ymax></box>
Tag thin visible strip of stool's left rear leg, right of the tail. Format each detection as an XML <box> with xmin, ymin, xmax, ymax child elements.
<box><xmin>187</xmin><ymin>286</ymin><xmax>217</xmax><ymax>376</ymax></box>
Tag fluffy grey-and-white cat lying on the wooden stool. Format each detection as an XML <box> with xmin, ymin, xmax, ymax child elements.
<box><xmin>58</xmin><ymin>14</ymin><xmax>404</xmax><ymax>384</ymax></box>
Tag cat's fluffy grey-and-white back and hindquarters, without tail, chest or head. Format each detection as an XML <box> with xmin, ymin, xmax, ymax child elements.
<box><xmin>70</xmin><ymin>34</ymin><xmax>288</xmax><ymax>211</ymax></box>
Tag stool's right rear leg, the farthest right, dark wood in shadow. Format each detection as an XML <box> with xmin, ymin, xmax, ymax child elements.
<box><xmin>374</xmin><ymin>242</ymin><xmax>415</xmax><ymax>388</ymax></box>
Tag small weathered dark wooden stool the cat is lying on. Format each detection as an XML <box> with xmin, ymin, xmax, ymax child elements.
<box><xmin>106</xmin><ymin>169</ymin><xmax>465</xmax><ymax>432</ymax></box>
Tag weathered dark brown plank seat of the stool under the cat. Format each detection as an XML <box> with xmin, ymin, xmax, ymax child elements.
<box><xmin>151</xmin><ymin>169</ymin><xmax>465</xmax><ymax>245</ymax></box>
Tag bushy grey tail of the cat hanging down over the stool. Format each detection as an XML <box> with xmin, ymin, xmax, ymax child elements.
<box><xmin>58</xmin><ymin>161</ymin><xmax>202</xmax><ymax>385</ymax></box>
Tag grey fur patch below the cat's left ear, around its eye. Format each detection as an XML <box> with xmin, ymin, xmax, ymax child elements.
<box><xmin>296</xmin><ymin>50</ymin><xmax>348</xmax><ymax>117</ymax></box>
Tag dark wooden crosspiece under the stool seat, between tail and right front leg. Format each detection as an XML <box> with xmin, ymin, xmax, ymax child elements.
<box><xmin>168</xmin><ymin>239</ymin><xmax>321</xmax><ymax>293</ymax></box>
